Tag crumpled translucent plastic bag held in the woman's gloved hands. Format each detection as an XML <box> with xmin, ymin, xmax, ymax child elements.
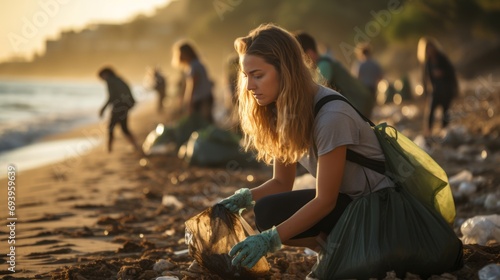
<box><xmin>185</xmin><ymin>204</ymin><xmax>270</xmax><ymax>279</ymax></box>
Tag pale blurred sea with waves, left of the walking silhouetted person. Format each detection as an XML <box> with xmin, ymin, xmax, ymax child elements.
<box><xmin>0</xmin><ymin>81</ymin><xmax>106</xmax><ymax>154</ymax></box>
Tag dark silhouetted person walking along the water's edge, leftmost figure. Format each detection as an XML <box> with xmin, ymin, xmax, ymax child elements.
<box><xmin>98</xmin><ymin>67</ymin><xmax>142</xmax><ymax>153</ymax></box>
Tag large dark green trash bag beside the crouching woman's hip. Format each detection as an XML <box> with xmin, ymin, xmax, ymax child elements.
<box><xmin>313</xmin><ymin>187</ymin><xmax>463</xmax><ymax>279</ymax></box>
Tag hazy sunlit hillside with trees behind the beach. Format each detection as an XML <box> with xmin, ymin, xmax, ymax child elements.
<box><xmin>0</xmin><ymin>0</ymin><xmax>500</xmax><ymax>82</ymax></box>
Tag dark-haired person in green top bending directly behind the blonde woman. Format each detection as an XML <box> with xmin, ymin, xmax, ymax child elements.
<box><xmin>295</xmin><ymin>31</ymin><xmax>375</xmax><ymax>117</ymax></box>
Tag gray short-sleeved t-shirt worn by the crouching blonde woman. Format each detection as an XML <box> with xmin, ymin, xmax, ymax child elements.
<box><xmin>299</xmin><ymin>86</ymin><xmax>394</xmax><ymax>199</ymax></box>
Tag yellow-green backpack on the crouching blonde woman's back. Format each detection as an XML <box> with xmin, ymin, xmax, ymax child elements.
<box><xmin>373</xmin><ymin>123</ymin><xmax>456</xmax><ymax>224</ymax></box>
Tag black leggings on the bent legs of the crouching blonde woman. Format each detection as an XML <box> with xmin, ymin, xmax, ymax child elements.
<box><xmin>254</xmin><ymin>189</ymin><xmax>352</xmax><ymax>239</ymax></box>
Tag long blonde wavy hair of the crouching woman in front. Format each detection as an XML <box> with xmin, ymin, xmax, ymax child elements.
<box><xmin>234</xmin><ymin>24</ymin><xmax>317</xmax><ymax>164</ymax></box>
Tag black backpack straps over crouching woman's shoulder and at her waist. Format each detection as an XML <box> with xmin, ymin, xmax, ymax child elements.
<box><xmin>314</xmin><ymin>94</ymin><xmax>385</xmax><ymax>174</ymax></box>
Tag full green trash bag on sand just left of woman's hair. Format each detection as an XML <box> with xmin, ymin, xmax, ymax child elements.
<box><xmin>179</xmin><ymin>125</ymin><xmax>256</xmax><ymax>166</ymax></box>
